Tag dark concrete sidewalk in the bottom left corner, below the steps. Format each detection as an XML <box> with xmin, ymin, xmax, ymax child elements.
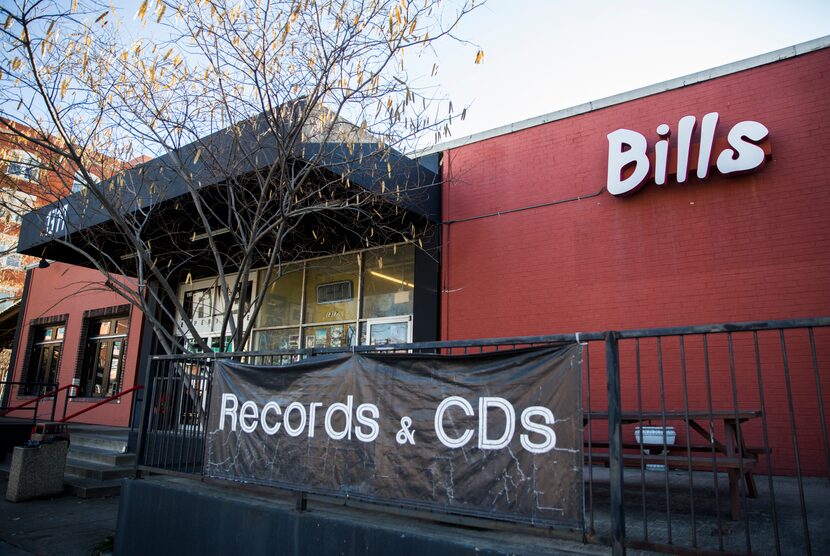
<box><xmin>0</xmin><ymin>479</ymin><xmax>118</xmax><ymax>556</ymax></box>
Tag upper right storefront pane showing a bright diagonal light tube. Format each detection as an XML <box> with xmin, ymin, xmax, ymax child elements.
<box><xmin>361</xmin><ymin>245</ymin><xmax>415</xmax><ymax>318</ymax></box>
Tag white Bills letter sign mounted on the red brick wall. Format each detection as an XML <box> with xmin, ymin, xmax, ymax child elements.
<box><xmin>607</xmin><ymin>112</ymin><xmax>772</xmax><ymax>195</ymax></box>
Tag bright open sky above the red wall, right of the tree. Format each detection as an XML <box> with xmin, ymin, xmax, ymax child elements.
<box><xmin>428</xmin><ymin>0</ymin><xmax>830</xmax><ymax>143</ymax></box>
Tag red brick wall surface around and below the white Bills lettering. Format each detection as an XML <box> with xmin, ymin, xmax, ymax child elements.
<box><xmin>441</xmin><ymin>46</ymin><xmax>830</xmax><ymax>474</ymax></box>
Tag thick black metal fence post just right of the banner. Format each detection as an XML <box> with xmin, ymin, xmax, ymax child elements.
<box><xmin>605</xmin><ymin>331</ymin><xmax>625</xmax><ymax>556</ymax></box>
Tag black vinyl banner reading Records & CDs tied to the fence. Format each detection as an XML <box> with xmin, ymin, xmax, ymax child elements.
<box><xmin>205</xmin><ymin>344</ymin><xmax>583</xmax><ymax>527</ymax></box>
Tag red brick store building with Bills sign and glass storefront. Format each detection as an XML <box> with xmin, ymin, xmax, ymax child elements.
<box><xmin>8</xmin><ymin>38</ymin><xmax>830</xmax><ymax>473</ymax></box>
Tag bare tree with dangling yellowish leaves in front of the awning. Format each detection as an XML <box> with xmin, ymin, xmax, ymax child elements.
<box><xmin>0</xmin><ymin>0</ymin><xmax>483</xmax><ymax>352</ymax></box>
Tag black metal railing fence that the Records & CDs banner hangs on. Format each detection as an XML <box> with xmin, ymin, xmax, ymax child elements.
<box><xmin>133</xmin><ymin>318</ymin><xmax>830</xmax><ymax>554</ymax></box>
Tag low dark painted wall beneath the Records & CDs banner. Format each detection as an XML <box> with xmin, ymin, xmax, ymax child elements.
<box><xmin>115</xmin><ymin>479</ymin><xmax>562</xmax><ymax>556</ymax></box>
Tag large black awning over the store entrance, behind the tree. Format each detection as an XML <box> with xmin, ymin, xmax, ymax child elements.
<box><xmin>18</xmin><ymin>111</ymin><xmax>441</xmax><ymax>265</ymax></box>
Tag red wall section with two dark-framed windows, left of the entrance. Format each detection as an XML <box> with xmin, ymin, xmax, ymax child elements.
<box><xmin>3</xmin><ymin>262</ymin><xmax>143</xmax><ymax>427</ymax></box>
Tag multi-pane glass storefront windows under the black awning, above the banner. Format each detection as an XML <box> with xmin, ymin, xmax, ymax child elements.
<box><xmin>182</xmin><ymin>245</ymin><xmax>415</xmax><ymax>352</ymax></box>
